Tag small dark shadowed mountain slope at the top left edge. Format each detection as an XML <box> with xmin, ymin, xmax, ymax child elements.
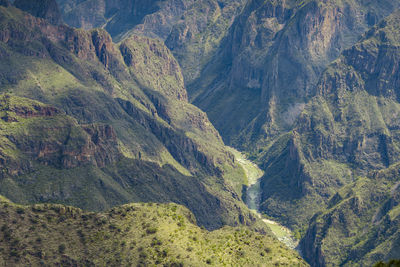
<box><xmin>13</xmin><ymin>0</ymin><xmax>62</xmax><ymax>25</ymax></box>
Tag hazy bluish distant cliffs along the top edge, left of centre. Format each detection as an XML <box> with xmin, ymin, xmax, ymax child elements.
<box><xmin>58</xmin><ymin>0</ymin><xmax>184</xmax><ymax>39</ymax></box>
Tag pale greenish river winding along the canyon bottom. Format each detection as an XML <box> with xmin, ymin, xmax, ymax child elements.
<box><xmin>231</xmin><ymin>148</ymin><xmax>300</xmax><ymax>252</ymax></box>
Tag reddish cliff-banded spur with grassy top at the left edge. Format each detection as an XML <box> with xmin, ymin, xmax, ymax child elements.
<box><xmin>1</xmin><ymin>94</ymin><xmax>121</xmax><ymax>178</ymax></box>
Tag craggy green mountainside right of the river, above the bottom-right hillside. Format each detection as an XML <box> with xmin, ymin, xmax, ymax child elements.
<box><xmin>250</xmin><ymin>1</ymin><xmax>400</xmax><ymax>233</ymax></box>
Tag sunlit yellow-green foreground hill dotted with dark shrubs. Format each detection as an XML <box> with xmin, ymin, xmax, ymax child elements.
<box><xmin>0</xmin><ymin>198</ymin><xmax>307</xmax><ymax>266</ymax></box>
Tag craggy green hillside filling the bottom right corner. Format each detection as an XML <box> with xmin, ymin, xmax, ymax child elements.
<box><xmin>301</xmin><ymin>164</ymin><xmax>400</xmax><ymax>266</ymax></box>
